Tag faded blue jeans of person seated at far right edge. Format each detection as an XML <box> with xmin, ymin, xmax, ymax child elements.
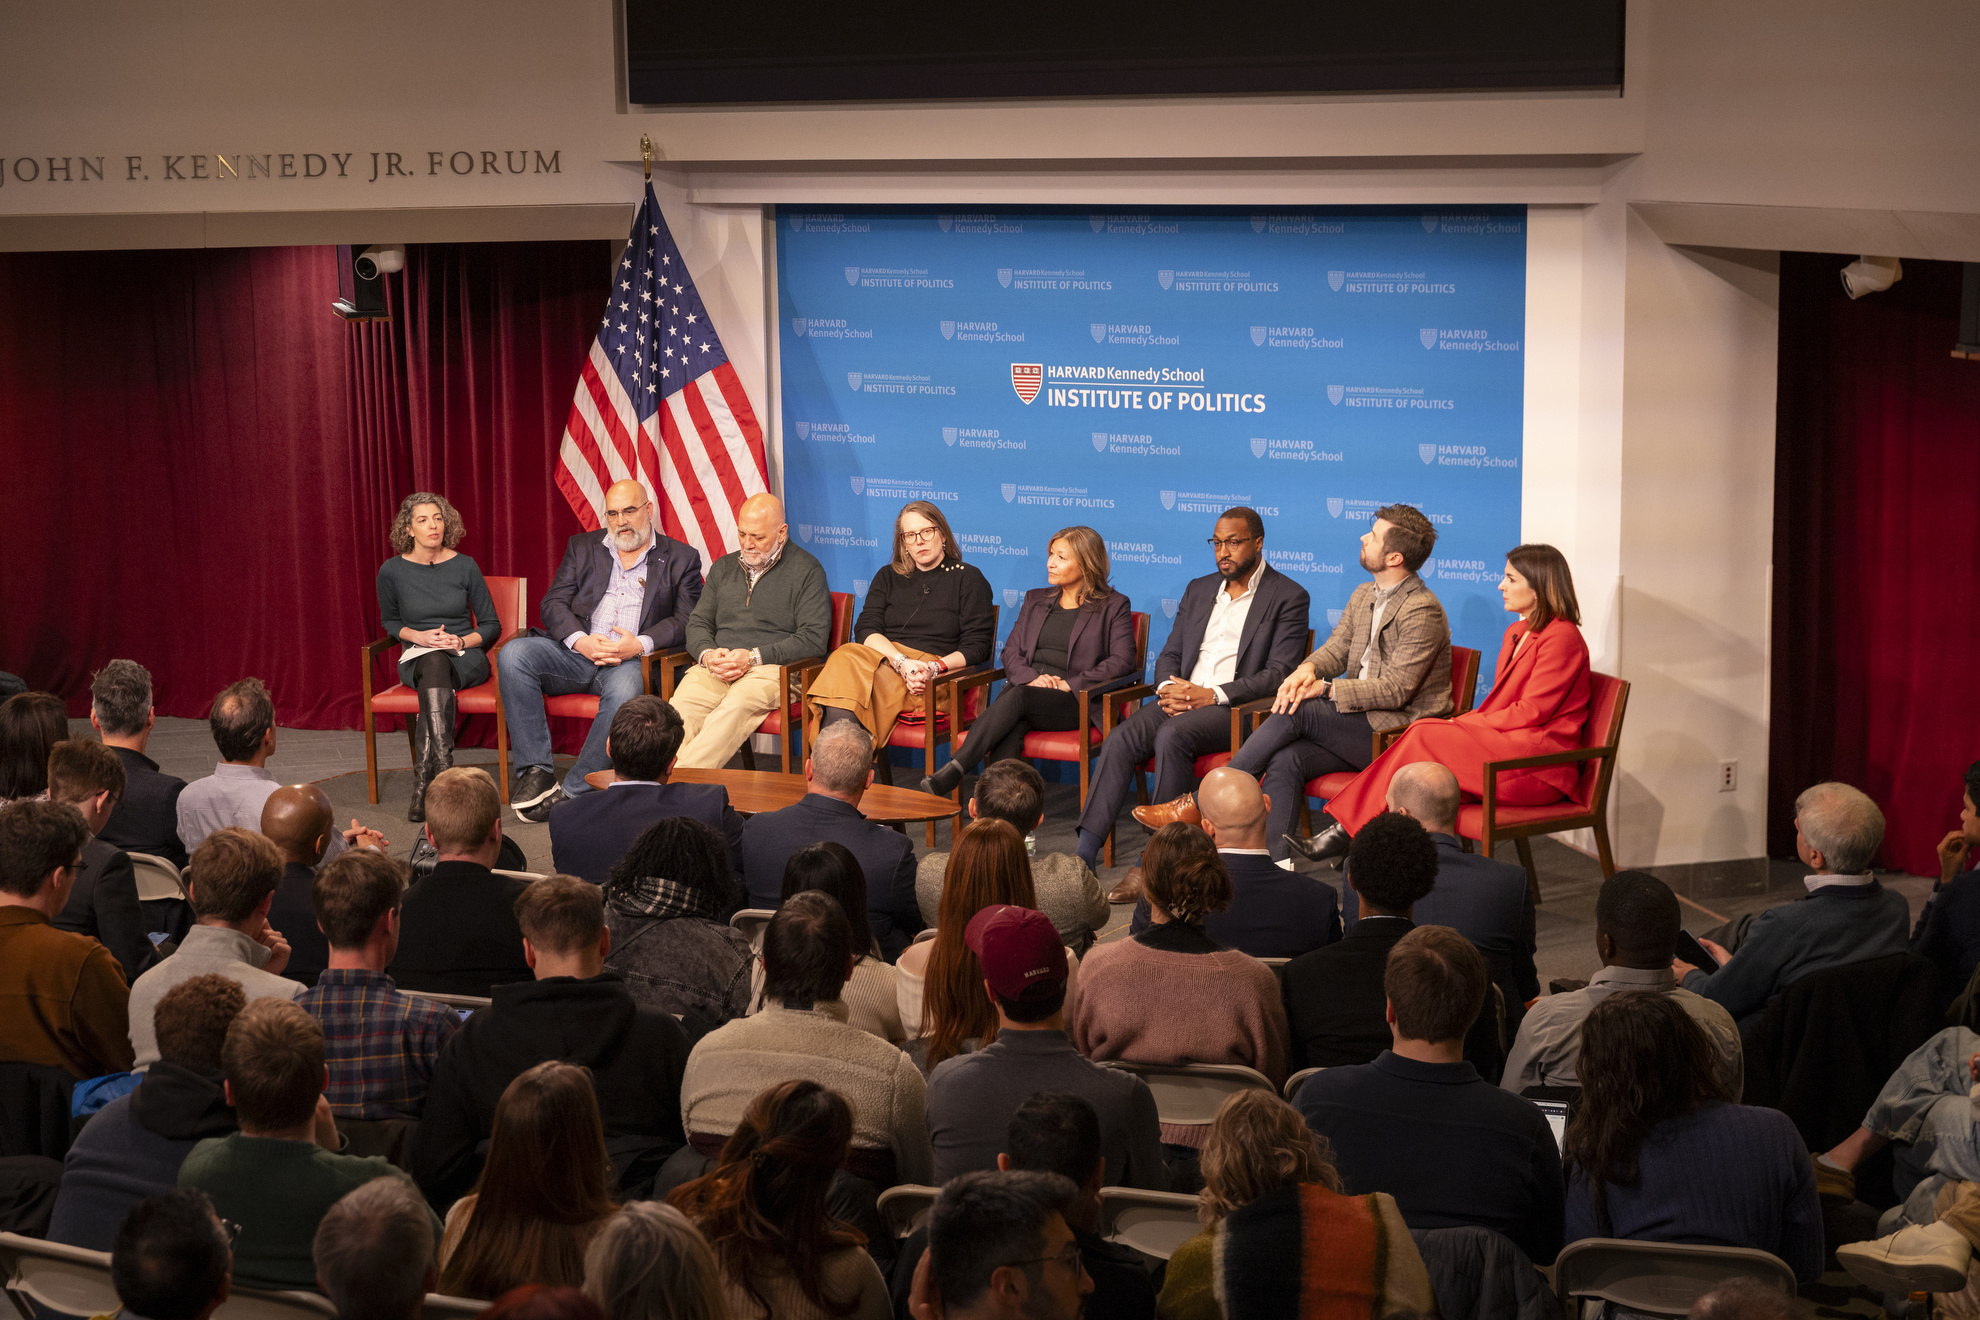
<box><xmin>1863</xmin><ymin>1027</ymin><xmax>1980</xmax><ymax>1233</ymax></box>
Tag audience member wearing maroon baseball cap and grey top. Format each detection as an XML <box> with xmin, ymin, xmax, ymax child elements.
<box><xmin>929</xmin><ymin>906</ymin><xmax>1168</xmax><ymax>1191</ymax></box>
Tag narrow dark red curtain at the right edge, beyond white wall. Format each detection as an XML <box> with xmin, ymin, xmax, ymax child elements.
<box><xmin>1768</xmin><ymin>253</ymin><xmax>1980</xmax><ymax>875</ymax></box>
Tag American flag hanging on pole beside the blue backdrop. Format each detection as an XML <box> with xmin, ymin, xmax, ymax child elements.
<box><xmin>556</xmin><ymin>184</ymin><xmax>770</xmax><ymax>564</ymax></box>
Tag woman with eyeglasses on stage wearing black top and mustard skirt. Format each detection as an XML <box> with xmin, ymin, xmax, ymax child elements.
<box><xmin>804</xmin><ymin>499</ymin><xmax>996</xmax><ymax>746</ymax></box>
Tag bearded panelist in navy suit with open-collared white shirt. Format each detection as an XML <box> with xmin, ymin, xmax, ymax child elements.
<box><xmin>1079</xmin><ymin>507</ymin><xmax>1309</xmax><ymax>886</ymax></box>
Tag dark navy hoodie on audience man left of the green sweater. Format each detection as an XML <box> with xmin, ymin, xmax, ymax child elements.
<box><xmin>48</xmin><ymin>1059</ymin><xmax>238</xmax><ymax>1251</ymax></box>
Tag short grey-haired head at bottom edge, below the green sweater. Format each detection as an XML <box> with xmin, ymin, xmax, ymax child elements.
<box><xmin>311</xmin><ymin>1178</ymin><xmax>440</xmax><ymax>1320</ymax></box>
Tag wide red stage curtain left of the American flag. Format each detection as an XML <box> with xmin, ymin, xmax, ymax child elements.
<box><xmin>0</xmin><ymin>241</ymin><xmax>614</xmax><ymax>728</ymax></box>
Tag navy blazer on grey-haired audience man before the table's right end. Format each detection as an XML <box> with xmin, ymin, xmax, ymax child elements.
<box><xmin>740</xmin><ymin>794</ymin><xmax>921</xmax><ymax>962</ymax></box>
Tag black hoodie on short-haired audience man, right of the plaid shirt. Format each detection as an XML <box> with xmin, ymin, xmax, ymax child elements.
<box><xmin>412</xmin><ymin>968</ymin><xmax>687</xmax><ymax>1211</ymax></box>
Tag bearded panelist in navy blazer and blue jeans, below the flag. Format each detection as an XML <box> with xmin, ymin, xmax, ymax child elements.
<box><xmin>499</xmin><ymin>481</ymin><xmax>701</xmax><ymax>823</ymax></box>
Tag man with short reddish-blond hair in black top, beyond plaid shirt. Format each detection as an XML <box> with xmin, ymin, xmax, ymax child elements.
<box><xmin>392</xmin><ymin>766</ymin><xmax>531</xmax><ymax>997</ymax></box>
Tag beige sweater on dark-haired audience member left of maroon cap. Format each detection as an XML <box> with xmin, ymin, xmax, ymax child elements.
<box><xmin>681</xmin><ymin>1001</ymin><xmax>934</xmax><ymax>1183</ymax></box>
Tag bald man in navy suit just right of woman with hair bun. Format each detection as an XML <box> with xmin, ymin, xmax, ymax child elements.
<box><xmin>1129</xmin><ymin>766</ymin><xmax>1340</xmax><ymax>958</ymax></box>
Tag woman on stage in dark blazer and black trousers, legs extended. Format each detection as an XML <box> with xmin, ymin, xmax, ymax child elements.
<box><xmin>921</xmin><ymin>526</ymin><xmax>1135</xmax><ymax>798</ymax></box>
